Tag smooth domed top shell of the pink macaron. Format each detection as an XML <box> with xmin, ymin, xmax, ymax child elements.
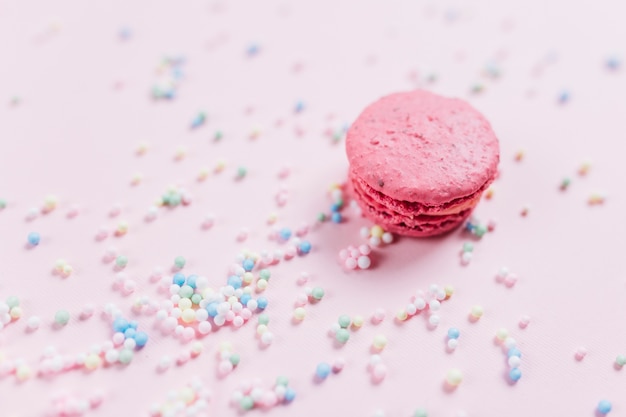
<box><xmin>346</xmin><ymin>90</ymin><xmax>500</xmax><ymax>206</ymax></box>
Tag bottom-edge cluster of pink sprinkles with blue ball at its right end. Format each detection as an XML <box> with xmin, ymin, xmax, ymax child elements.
<box><xmin>231</xmin><ymin>376</ymin><xmax>296</xmax><ymax>411</ymax></box>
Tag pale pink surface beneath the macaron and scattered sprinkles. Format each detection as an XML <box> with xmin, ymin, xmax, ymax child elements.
<box><xmin>0</xmin><ymin>0</ymin><xmax>626</xmax><ymax>417</ymax></box>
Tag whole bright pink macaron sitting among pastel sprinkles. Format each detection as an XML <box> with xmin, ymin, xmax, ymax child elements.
<box><xmin>346</xmin><ymin>90</ymin><xmax>500</xmax><ymax>237</ymax></box>
